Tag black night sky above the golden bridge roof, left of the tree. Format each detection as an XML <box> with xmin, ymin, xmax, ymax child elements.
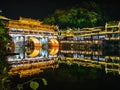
<box><xmin>0</xmin><ymin>0</ymin><xmax>80</xmax><ymax>19</ymax></box>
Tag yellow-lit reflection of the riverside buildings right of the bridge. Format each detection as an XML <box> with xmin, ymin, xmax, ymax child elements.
<box><xmin>59</xmin><ymin>49</ymin><xmax>120</xmax><ymax>74</ymax></box>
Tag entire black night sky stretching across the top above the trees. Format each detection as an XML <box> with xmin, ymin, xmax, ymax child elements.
<box><xmin>0</xmin><ymin>0</ymin><xmax>120</xmax><ymax>19</ymax></box>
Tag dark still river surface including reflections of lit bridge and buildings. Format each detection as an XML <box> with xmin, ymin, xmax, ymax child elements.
<box><xmin>8</xmin><ymin>42</ymin><xmax>120</xmax><ymax>90</ymax></box>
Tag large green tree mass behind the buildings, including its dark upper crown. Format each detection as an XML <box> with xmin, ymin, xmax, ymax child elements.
<box><xmin>44</xmin><ymin>2</ymin><xmax>106</xmax><ymax>29</ymax></box>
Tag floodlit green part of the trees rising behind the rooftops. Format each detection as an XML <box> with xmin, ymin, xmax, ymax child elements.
<box><xmin>43</xmin><ymin>8</ymin><xmax>105</xmax><ymax>28</ymax></box>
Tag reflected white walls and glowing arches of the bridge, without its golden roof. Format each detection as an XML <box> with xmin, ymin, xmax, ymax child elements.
<box><xmin>8</xmin><ymin>47</ymin><xmax>59</xmax><ymax>62</ymax></box>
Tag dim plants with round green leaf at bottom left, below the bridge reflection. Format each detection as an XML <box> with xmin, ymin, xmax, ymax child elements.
<box><xmin>10</xmin><ymin>75</ymin><xmax>48</xmax><ymax>90</ymax></box>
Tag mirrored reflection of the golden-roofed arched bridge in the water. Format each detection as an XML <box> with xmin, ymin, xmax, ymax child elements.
<box><xmin>8</xmin><ymin>44</ymin><xmax>59</xmax><ymax>77</ymax></box>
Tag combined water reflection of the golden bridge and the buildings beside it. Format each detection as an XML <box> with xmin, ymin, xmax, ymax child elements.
<box><xmin>8</xmin><ymin>44</ymin><xmax>120</xmax><ymax>77</ymax></box>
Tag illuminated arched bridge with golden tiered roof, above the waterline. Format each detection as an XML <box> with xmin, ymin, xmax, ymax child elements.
<box><xmin>6</xmin><ymin>17</ymin><xmax>59</xmax><ymax>57</ymax></box>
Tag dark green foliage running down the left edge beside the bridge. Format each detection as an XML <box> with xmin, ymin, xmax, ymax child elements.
<box><xmin>0</xmin><ymin>16</ymin><xmax>10</xmax><ymax>90</ymax></box>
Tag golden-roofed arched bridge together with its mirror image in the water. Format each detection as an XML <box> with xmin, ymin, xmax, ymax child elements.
<box><xmin>3</xmin><ymin>17</ymin><xmax>59</xmax><ymax>77</ymax></box>
